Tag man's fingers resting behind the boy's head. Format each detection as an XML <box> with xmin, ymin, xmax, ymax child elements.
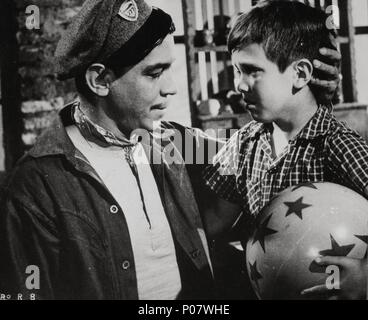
<box><xmin>311</xmin><ymin>48</ymin><xmax>341</xmax><ymax>101</ymax></box>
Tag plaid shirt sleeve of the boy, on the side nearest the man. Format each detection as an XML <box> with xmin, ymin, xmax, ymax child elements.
<box><xmin>203</xmin><ymin>133</ymin><xmax>241</xmax><ymax>204</ymax></box>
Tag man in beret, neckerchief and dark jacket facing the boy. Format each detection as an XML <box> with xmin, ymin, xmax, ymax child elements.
<box><xmin>0</xmin><ymin>0</ymin><xmax>340</xmax><ymax>299</ymax></box>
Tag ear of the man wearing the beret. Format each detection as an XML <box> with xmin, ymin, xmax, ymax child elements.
<box><xmin>86</xmin><ymin>63</ymin><xmax>113</xmax><ymax>97</ymax></box>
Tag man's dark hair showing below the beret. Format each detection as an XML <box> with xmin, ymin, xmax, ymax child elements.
<box><xmin>75</xmin><ymin>7</ymin><xmax>175</xmax><ymax>102</ymax></box>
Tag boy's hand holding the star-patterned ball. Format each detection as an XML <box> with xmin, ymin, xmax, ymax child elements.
<box><xmin>301</xmin><ymin>256</ymin><xmax>368</xmax><ymax>300</ymax></box>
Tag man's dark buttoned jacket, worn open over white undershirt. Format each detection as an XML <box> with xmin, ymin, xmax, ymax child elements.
<box><xmin>0</xmin><ymin>107</ymin><xmax>214</xmax><ymax>299</ymax></box>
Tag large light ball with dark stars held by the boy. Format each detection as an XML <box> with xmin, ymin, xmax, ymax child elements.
<box><xmin>246</xmin><ymin>183</ymin><xmax>368</xmax><ymax>299</ymax></box>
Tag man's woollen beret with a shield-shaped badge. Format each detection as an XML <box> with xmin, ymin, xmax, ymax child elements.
<box><xmin>55</xmin><ymin>0</ymin><xmax>159</xmax><ymax>80</ymax></box>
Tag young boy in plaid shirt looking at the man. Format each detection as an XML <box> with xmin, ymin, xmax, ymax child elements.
<box><xmin>205</xmin><ymin>1</ymin><xmax>368</xmax><ymax>299</ymax></box>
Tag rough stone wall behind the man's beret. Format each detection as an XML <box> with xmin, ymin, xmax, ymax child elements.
<box><xmin>16</xmin><ymin>0</ymin><xmax>83</xmax><ymax>147</ymax></box>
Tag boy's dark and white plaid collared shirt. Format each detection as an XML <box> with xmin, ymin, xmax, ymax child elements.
<box><xmin>204</xmin><ymin>106</ymin><xmax>368</xmax><ymax>216</ymax></box>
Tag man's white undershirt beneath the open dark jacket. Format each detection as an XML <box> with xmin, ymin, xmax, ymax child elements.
<box><xmin>66</xmin><ymin>126</ymin><xmax>181</xmax><ymax>300</ymax></box>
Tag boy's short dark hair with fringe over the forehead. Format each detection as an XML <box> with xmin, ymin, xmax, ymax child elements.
<box><xmin>228</xmin><ymin>0</ymin><xmax>336</xmax><ymax>73</ymax></box>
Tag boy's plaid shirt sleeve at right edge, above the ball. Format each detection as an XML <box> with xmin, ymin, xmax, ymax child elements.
<box><xmin>328</xmin><ymin>132</ymin><xmax>368</xmax><ymax>197</ymax></box>
